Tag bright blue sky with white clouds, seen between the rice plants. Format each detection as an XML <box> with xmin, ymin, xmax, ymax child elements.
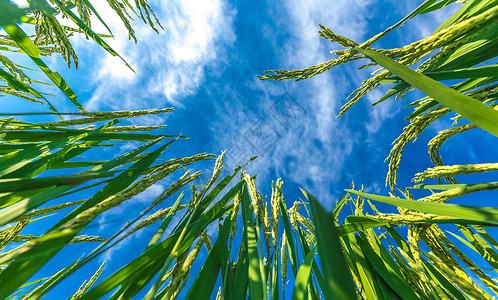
<box><xmin>4</xmin><ymin>0</ymin><xmax>496</xmax><ymax>297</ymax></box>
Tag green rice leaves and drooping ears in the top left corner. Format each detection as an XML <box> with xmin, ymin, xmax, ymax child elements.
<box><xmin>0</xmin><ymin>0</ymin><xmax>160</xmax><ymax>112</ymax></box>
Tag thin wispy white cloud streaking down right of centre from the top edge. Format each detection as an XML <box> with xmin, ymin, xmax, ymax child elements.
<box><xmin>263</xmin><ymin>0</ymin><xmax>458</xmax><ymax>203</ymax></box>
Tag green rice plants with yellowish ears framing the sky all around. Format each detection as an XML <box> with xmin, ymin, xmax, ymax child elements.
<box><xmin>0</xmin><ymin>0</ymin><xmax>498</xmax><ymax>299</ymax></box>
